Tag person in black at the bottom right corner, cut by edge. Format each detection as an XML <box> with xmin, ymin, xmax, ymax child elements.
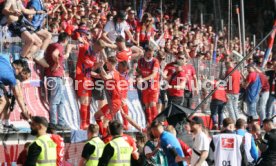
<box><xmin>257</xmin><ymin>119</ymin><xmax>276</xmax><ymax>166</ymax></box>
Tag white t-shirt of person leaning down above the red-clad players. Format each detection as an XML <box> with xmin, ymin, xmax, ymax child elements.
<box><xmin>104</xmin><ymin>20</ymin><xmax>129</xmax><ymax>43</ymax></box>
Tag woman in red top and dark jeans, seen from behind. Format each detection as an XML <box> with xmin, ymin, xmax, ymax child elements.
<box><xmin>210</xmin><ymin>80</ymin><xmax>227</xmax><ymax>130</ymax></box>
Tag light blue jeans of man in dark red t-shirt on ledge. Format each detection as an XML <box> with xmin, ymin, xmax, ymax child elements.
<box><xmin>47</xmin><ymin>77</ymin><xmax>65</xmax><ymax>126</ymax></box>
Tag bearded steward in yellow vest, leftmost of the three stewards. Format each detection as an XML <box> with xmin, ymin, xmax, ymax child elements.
<box><xmin>24</xmin><ymin>116</ymin><xmax>57</xmax><ymax>166</ymax></box>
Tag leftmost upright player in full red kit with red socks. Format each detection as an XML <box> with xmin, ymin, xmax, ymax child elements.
<box><xmin>76</xmin><ymin>39</ymin><xmax>104</xmax><ymax>129</ymax></box>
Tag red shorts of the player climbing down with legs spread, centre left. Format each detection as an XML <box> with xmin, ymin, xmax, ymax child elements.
<box><xmin>101</xmin><ymin>100</ymin><xmax>122</xmax><ymax>120</ymax></box>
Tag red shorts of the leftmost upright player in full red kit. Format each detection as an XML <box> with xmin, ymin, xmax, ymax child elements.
<box><xmin>77</xmin><ymin>80</ymin><xmax>93</xmax><ymax>97</ymax></box>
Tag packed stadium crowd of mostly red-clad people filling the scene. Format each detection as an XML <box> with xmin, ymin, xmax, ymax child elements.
<box><xmin>0</xmin><ymin>0</ymin><xmax>276</xmax><ymax>166</ymax></box>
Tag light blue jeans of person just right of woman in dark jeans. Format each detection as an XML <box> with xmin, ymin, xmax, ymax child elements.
<box><xmin>226</xmin><ymin>93</ymin><xmax>239</xmax><ymax>121</ymax></box>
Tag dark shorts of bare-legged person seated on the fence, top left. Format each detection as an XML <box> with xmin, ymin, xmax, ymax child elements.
<box><xmin>9</xmin><ymin>17</ymin><xmax>35</xmax><ymax>37</ymax></box>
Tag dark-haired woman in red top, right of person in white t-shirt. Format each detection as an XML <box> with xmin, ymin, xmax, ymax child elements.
<box><xmin>137</xmin><ymin>13</ymin><xmax>155</xmax><ymax>48</ymax></box>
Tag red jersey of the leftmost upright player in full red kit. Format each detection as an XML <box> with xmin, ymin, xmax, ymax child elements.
<box><xmin>76</xmin><ymin>44</ymin><xmax>97</xmax><ymax>80</ymax></box>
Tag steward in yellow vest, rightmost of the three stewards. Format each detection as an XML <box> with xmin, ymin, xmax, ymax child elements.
<box><xmin>98</xmin><ymin>120</ymin><xmax>133</xmax><ymax>166</ymax></box>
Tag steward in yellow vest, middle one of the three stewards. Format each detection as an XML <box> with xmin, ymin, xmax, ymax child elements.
<box><xmin>79</xmin><ymin>124</ymin><xmax>105</xmax><ymax>166</ymax></box>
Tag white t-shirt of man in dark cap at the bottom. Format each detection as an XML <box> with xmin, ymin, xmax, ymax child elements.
<box><xmin>191</xmin><ymin>132</ymin><xmax>210</xmax><ymax>166</ymax></box>
